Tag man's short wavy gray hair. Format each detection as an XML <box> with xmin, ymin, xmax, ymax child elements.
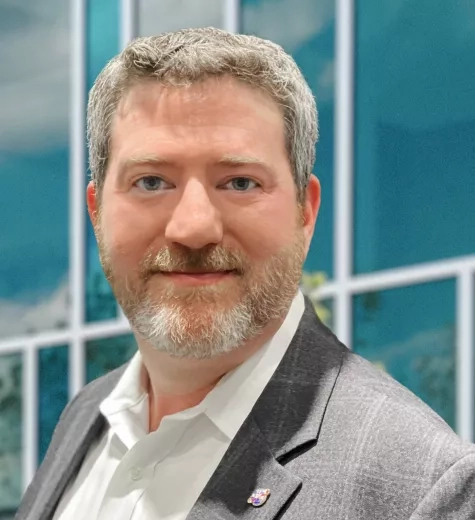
<box><xmin>87</xmin><ymin>28</ymin><xmax>318</xmax><ymax>201</ymax></box>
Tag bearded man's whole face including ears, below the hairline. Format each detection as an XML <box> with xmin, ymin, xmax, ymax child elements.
<box><xmin>88</xmin><ymin>78</ymin><xmax>320</xmax><ymax>358</ymax></box>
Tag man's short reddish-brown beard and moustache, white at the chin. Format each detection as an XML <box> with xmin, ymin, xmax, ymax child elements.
<box><xmin>97</xmin><ymin>229</ymin><xmax>305</xmax><ymax>359</ymax></box>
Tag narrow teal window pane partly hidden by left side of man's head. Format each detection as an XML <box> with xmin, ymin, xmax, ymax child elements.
<box><xmin>86</xmin><ymin>0</ymin><xmax>120</xmax><ymax>322</ymax></box>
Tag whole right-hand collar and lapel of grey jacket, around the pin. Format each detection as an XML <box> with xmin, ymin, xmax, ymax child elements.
<box><xmin>187</xmin><ymin>301</ymin><xmax>346</xmax><ymax>520</ymax></box>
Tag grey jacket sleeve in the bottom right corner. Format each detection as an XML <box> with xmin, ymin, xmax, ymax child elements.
<box><xmin>410</xmin><ymin>452</ymin><xmax>475</xmax><ymax>520</ymax></box>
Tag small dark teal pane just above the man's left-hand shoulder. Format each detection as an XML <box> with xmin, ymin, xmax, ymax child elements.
<box><xmin>38</xmin><ymin>345</ymin><xmax>69</xmax><ymax>464</ymax></box>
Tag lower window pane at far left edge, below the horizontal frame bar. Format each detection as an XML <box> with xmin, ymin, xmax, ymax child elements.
<box><xmin>0</xmin><ymin>354</ymin><xmax>23</xmax><ymax>517</ymax></box>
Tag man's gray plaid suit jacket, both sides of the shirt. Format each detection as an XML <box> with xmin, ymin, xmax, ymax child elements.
<box><xmin>16</xmin><ymin>302</ymin><xmax>475</xmax><ymax>520</ymax></box>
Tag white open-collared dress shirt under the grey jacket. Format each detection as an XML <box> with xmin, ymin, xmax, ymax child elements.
<box><xmin>54</xmin><ymin>292</ymin><xmax>305</xmax><ymax>520</ymax></box>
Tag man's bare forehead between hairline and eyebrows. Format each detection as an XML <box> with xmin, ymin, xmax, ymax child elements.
<box><xmin>111</xmin><ymin>77</ymin><xmax>285</xmax><ymax>158</ymax></box>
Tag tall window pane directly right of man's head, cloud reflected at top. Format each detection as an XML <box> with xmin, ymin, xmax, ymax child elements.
<box><xmin>241</xmin><ymin>0</ymin><xmax>335</xmax><ymax>277</ymax></box>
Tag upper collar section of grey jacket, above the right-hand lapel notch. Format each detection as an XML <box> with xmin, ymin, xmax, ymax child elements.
<box><xmin>251</xmin><ymin>300</ymin><xmax>348</xmax><ymax>461</ymax></box>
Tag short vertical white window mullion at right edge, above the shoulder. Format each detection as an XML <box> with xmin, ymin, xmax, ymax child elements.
<box><xmin>455</xmin><ymin>268</ymin><xmax>475</xmax><ymax>442</ymax></box>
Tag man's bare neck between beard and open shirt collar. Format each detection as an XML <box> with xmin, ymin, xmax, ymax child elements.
<box><xmin>137</xmin><ymin>320</ymin><xmax>283</xmax><ymax>431</ymax></box>
